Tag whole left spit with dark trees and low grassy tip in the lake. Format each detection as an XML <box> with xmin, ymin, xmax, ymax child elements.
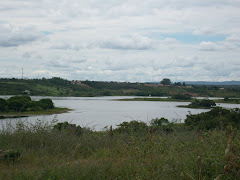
<box><xmin>0</xmin><ymin>95</ymin><xmax>69</xmax><ymax>118</ymax></box>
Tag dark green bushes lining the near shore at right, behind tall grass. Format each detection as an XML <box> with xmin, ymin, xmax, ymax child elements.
<box><xmin>113</xmin><ymin>107</ymin><xmax>240</xmax><ymax>133</ymax></box>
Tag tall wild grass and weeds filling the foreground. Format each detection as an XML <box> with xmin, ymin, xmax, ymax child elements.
<box><xmin>0</xmin><ymin>121</ymin><xmax>240</xmax><ymax>180</ymax></box>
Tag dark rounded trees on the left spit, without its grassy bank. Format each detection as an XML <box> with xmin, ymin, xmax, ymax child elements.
<box><xmin>0</xmin><ymin>95</ymin><xmax>54</xmax><ymax>112</ymax></box>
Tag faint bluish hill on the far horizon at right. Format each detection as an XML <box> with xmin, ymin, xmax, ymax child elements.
<box><xmin>185</xmin><ymin>81</ymin><xmax>240</xmax><ymax>86</ymax></box>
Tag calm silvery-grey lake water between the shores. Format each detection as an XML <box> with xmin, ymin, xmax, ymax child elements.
<box><xmin>0</xmin><ymin>96</ymin><xmax>240</xmax><ymax>130</ymax></box>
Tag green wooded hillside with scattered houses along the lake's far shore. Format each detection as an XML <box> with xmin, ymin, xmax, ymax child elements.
<box><xmin>0</xmin><ymin>77</ymin><xmax>240</xmax><ymax>99</ymax></box>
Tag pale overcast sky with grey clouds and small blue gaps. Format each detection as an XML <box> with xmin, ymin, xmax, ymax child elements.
<box><xmin>0</xmin><ymin>0</ymin><xmax>240</xmax><ymax>82</ymax></box>
